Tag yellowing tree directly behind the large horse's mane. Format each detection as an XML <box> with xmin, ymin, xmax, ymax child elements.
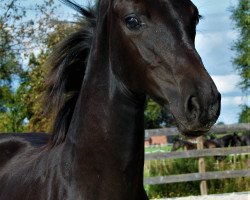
<box><xmin>25</xmin><ymin>23</ymin><xmax>77</xmax><ymax>132</ymax></box>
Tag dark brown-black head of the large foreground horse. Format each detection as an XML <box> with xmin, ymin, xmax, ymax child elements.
<box><xmin>104</xmin><ymin>0</ymin><xmax>221</xmax><ymax>136</ymax></box>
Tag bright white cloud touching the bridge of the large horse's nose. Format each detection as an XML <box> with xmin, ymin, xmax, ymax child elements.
<box><xmin>212</xmin><ymin>74</ymin><xmax>240</xmax><ymax>94</ymax></box>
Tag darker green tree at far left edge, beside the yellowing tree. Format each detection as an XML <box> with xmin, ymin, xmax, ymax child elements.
<box><xmin>0</xmin><ymin>18</ymin><xmax>25</xmax><ymax>132</ymax></box>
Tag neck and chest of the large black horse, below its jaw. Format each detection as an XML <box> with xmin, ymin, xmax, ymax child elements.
<box><xmin>65</xmin><ymin>35</ymin><xmax>145</xmax><ymax>199</ymax></box>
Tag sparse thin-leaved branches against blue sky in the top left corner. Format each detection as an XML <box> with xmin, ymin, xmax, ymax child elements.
<box><xmin>0</xmin><ymin>0</ymin><xmax>56</xmax><ymax>56</ymax></box>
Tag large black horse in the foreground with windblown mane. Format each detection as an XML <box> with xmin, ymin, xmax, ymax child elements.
<box><xmin>0</xmin><ymin>0</ymin><xmax>220</xmax><ymax>200</ymax></box>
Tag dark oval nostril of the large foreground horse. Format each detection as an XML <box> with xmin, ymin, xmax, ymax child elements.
<box><xmin>186</xmin><ymin>96</ymin><xmax>200</xmax><ymax>120</ymax></box>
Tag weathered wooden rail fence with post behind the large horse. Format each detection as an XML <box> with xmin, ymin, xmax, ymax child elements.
<box><xmin>144</xmin><ymin>124</ymin><xmax>250</xmax><ymax>195</ymax></box>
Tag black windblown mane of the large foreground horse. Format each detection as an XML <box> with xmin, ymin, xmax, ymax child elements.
<box><xmin>45</xmin><ymin>0</ymin><xmax>96</xmax><ymax>146</ymax></box>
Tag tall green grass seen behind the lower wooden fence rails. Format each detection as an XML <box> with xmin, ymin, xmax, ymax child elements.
<box><xmin>144</xmin><ymin>156</ymin><xmax>250</xmax><ymax>198</ymax></box>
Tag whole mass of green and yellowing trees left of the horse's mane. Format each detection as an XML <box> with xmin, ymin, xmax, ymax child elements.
<box><xmin>0</xmin><ymin>0</ymin><xmax>92</xmax><ymax>132</ymax></box>
